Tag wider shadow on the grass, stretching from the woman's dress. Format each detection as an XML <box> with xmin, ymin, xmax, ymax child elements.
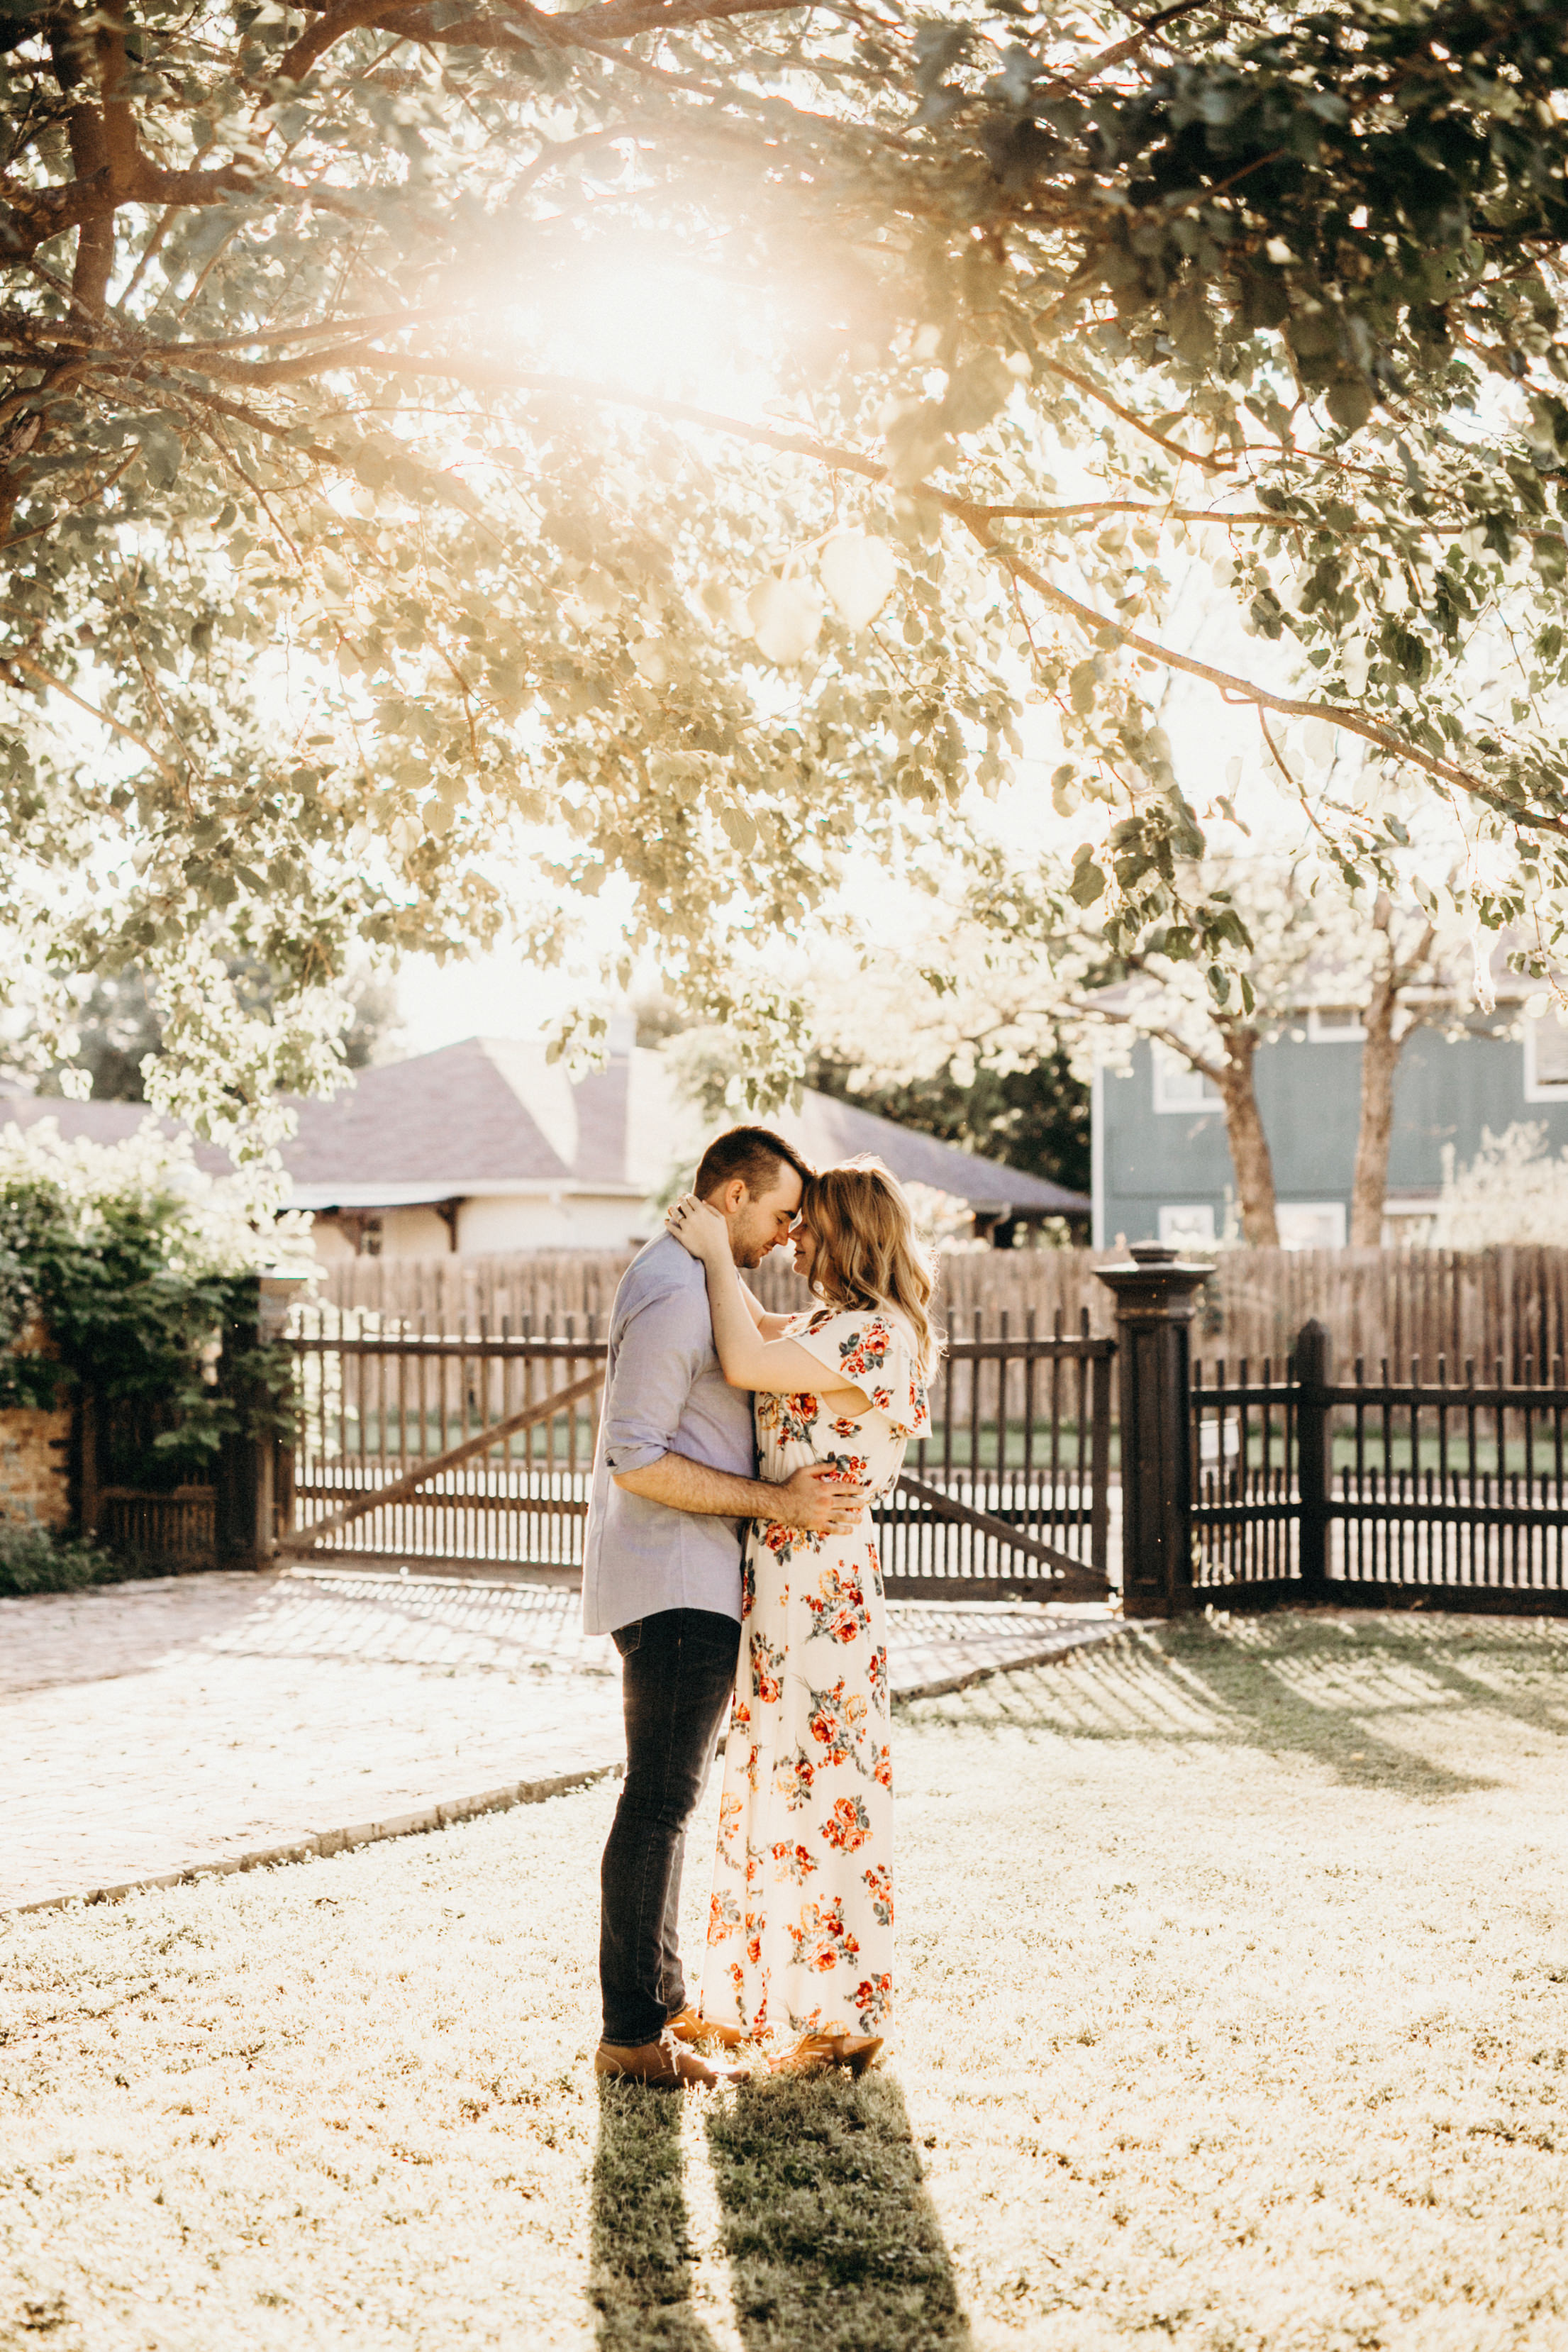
<box><xmin>708</xmin><ymin>2075</ymin><xmax>969</xmax><ymax>2352</ymax></box>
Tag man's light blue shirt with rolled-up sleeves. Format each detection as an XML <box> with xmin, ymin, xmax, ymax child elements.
<box><xmin>583</xmin><ymin>1235</ymin><xmax>757</xmax><ymax>1632</ymax></box>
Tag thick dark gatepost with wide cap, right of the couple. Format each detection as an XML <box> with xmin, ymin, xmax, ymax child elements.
<box><xmin>1096</xmin><ymin>1242</ymin><xmax>1213</xmax><ymax>1616</ymax></box>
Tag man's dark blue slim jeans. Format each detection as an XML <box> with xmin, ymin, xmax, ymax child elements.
<box><xmin>599</xmin><ymin>1609</ymin><xmax>740</xmax><ymax>2048</ymax></box>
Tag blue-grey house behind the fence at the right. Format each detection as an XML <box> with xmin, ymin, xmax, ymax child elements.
<box><xmin>1093</xmin><ymin>1004</ymin><xmax>1568</xmax><ymax>1249</ymax></box>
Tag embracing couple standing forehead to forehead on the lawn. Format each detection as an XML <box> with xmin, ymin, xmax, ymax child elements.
<box><xmin>583</xmin><ymin>1126</ymin><xmax>938</xmax><ymax>2089</ymax></box>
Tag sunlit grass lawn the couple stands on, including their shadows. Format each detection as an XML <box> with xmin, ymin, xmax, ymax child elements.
<box><xmin>0</xmin><ymin>1616</ymin><xmax>1568</xmax><ymax>2352</ymax></box>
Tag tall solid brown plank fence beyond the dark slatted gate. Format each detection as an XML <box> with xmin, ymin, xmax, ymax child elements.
<box><xmin>318</xmin><ymin>1249</ymin><xmax>1568</xmax><ymax>1380</ymax></box>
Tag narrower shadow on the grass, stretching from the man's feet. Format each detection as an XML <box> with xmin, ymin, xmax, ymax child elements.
<box><xmin>588</xmin><ymin>2082</ymin><xmax>715</xmax><ymax>2352</ymax></box>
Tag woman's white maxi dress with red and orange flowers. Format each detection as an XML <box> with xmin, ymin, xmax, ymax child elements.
<box><xmin>701</xmin><ymin>1308</ymin><xmax>931</xmax><ymax>2037</ymax></box>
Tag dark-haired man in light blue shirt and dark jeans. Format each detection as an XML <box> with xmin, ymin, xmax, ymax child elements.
<box><xmin>583</xmin><ymin>1126</ymin><xmax>865</xmax><ymax>2089</ymax></box>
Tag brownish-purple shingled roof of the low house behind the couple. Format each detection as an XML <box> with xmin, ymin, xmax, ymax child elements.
<box><xmin>0</xmin><ymin>1037</ymin><xmax>1089</xmax><ymax>1216</ymax></box>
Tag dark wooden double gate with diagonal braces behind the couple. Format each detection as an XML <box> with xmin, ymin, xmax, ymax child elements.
<box><xmin>279</xmin><ymin>1305</ymin><xmax>1114</xmax><ymax>1599</ymax></box>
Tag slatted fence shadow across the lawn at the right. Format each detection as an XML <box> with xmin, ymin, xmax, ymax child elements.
<box><xmin>901</xmin><ymin>1611</ymin><xmax>1568</xmax><ymax>1799</ymax></box>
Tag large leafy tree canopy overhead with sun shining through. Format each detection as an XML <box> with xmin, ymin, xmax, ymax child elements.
<box><xmin>0</xmin><ymin>0</ymin><xmax>1568</xmax><ymax>1138</ymax></box>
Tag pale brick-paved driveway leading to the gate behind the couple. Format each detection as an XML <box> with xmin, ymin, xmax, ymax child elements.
<box><xmin>0</xmin><ymin>1569</ymin><xmax>1121</xmax><ymax>1912</ymax></box>
